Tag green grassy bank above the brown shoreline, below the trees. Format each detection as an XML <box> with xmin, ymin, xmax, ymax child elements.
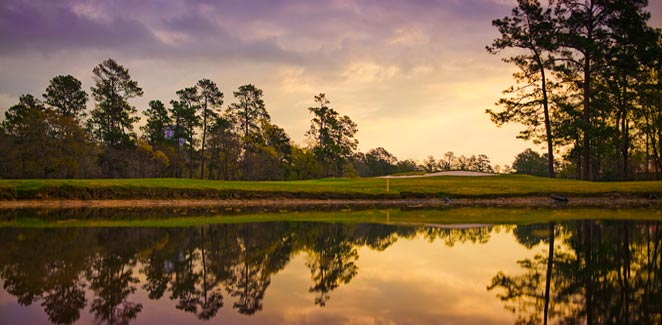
<box><xmin>0</xmin><ymin>175</ymin><xmax>662</xmax><ymax>200</ymax></box>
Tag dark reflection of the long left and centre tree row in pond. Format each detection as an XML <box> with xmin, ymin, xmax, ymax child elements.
<box><xmin>0</xmin><ymin>222</ymin><xmax>498</xmax><ymax>323</ymax></box>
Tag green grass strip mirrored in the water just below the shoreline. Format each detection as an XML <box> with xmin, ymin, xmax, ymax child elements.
<box><xmin>0</xmin><ymin>208</ymin><xmax>662</xmax><ymax>228</ymax></box>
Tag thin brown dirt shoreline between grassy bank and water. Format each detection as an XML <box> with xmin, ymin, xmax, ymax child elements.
<box><xmin>0</xmin><ymin>196</ymin><xmax>662</xmax><ymax>210</ymax></box>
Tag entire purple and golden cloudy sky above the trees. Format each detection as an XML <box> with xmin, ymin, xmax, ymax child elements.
<box><xmin>0</xmin><ymin>0</ymin><xmax>662</xmax><ymax>165</ymax></box>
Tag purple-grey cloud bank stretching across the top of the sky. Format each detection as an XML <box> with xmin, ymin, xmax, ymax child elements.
<box><xmin>0</xmin><ymin>0</ymin><xmax>512</xmax><ymax>68</ymax></box>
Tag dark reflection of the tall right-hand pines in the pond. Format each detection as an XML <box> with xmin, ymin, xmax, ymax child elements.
<box><xmin>488</xmin><ymin>220</ymin><xmax>662</xmax><ymax>324</ymax></box>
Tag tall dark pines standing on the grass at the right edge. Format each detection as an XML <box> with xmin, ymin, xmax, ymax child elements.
<box><xmin>487</xmin><ymin>0</ymin><xmax>662</xmax><ymax>180</ymax></box>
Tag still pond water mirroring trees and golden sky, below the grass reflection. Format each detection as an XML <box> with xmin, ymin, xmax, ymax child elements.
<box><xmin>0</xmin><ymin>210</ymin><xmax>662</xmax><ymax>324</ymax></box>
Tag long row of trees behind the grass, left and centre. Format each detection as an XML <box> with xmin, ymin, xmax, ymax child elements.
<box><xmin>0</xmin><ymin>59</ymin><xmax>506</xmax><ymax>180</ymax></box>
